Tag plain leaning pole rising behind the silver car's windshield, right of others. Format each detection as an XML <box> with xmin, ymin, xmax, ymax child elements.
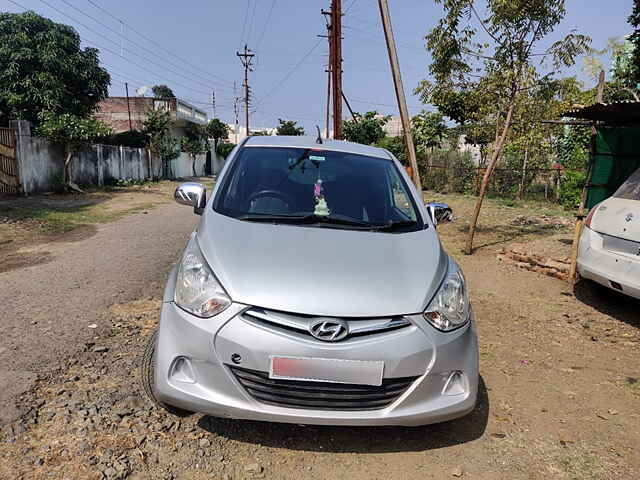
<box><xmin>378</xmin><ymin>0</ymin><xmax>422</xmax><ymax>191</ymax></box>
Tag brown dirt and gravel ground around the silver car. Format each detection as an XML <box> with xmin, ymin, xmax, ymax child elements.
<box><xmin>0</xmin><ymin>193</ymin><xmax>640</xmax><ymax>480</ymax></box>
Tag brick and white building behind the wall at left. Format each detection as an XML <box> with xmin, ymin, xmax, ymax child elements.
<box><xmin>93</xmin><ymin>97</ymin><xmax>207</xmax><ymax>137</ymax></box>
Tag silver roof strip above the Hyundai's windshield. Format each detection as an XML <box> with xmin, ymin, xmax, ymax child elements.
<box><xmin>244</xmin><ymin>135</ymin><xmax>391</xmax><ymax>160</ymax></box>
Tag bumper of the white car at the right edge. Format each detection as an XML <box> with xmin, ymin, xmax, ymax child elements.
<box><xmin>578</xmin><ymin>227</ymin><xmax>640</xmax><ymax>299</ymax></box>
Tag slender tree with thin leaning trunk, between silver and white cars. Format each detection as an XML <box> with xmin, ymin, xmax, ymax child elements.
<box><xmin>421</xmin><ymin>0</ymin><xmax>590</xmax><ymax>254</ymax></box>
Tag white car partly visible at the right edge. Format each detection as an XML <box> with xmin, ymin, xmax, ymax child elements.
<box><xmin>578</xmin><ymin>169</ymin><xmax>640</xmax><ymax>299</ymax></box>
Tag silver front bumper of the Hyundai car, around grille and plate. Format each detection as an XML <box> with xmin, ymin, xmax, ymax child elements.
<box><xmin>155</xmin><ymin>275</ymin><xmax>478</xmax><ymax>426</ymax></box>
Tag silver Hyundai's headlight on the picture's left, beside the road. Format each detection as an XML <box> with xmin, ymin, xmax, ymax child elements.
<box><xmin>174</xmin><ymin>238</ymin><xmax>231</xmax><ymax>318</ymax></box>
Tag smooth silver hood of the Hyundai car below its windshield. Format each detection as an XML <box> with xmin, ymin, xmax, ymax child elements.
<box><xmin>197</xmin><ymin>210</ymin><xmax>448</xmax><ymax>317</ymax></box>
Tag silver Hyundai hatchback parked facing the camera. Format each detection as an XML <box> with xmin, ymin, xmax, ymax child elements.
<box><xmin>142</xmin><ymin>136</ymin><xmax>478</xmax><ymax>426</ymax></box>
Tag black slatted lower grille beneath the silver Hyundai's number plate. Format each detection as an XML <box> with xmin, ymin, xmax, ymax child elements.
<box><xmin>229</xmin><ymin>366</ymin><xmax>418</xmax><ymax>410</ymax></box>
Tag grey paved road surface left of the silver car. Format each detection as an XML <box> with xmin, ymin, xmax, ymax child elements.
<box><xmin>0</xmin><ymin>203</ymin><xmax>197</xmax><ymax>423</ymax></box>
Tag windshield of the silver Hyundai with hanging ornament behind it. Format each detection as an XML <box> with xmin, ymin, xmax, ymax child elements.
<box><xmin>214</xmin><ymin>147</ymin><xmax>422</xmax><ymax>231</ymax></box>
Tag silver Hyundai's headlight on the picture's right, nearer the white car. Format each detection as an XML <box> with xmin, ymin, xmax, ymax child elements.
<box><xmin>423</xmin><ymin>260</ymin><xmax>470</xmax><ymax>332</ymax></box>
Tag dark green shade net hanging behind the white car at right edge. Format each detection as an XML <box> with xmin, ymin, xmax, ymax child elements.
<box><xmin>586</xmin><ymin>127</ymin><xmax>640</xmax><ymax>209</ymax></box>
